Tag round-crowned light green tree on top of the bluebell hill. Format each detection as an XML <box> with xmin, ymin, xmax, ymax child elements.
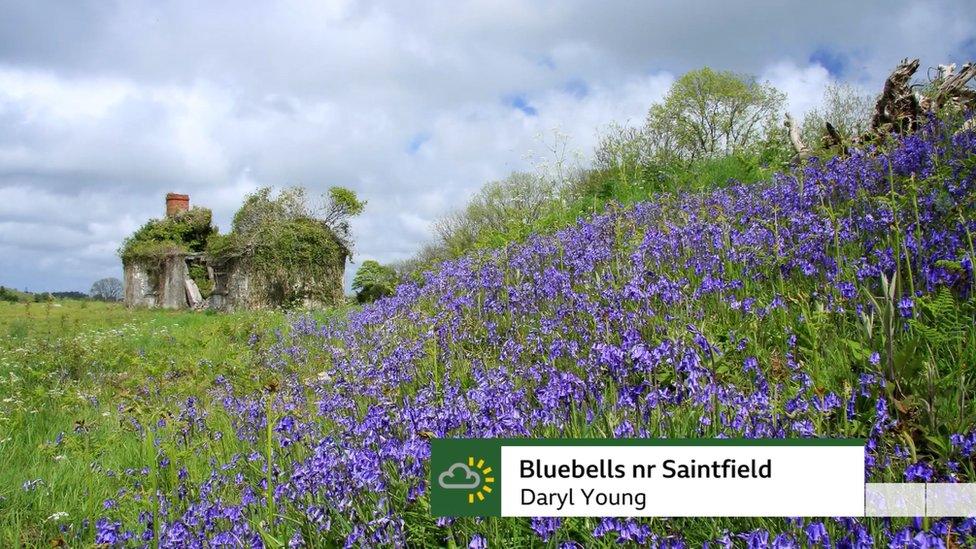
<box><xmin>644</xmin><ymin>67</ymin><xmax>785</xmax><ymax>159</ymax></box>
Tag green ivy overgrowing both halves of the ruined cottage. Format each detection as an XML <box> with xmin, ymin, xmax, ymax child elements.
<box><xmin>119</xmin><ymin>187</ymin><xmax>366</xmax><ymax>308</ymax></box>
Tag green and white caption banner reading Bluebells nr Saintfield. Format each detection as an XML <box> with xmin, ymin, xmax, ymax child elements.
<box><xmin>430</xmin><ymin>439</ymin><xmax>865</xmax><ymax>517</ymax></box>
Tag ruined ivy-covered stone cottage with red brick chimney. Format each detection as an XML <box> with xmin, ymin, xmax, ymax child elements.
<box><xmin>120</xmin><ymin>193</ymin><xmax>349</xmax><ymax>311</ymax></box>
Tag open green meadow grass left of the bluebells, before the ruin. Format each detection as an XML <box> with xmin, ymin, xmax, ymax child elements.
<box><xmin>0</xmin><ymin>301</ymin><xmax>286</xmax><ymax>547</ymax></box>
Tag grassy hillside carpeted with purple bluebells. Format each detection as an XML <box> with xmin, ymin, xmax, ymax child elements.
<box><xmin>0</xmin><ymin>119</ymin><xmax>976</xmax><ymax>547</ymax></box>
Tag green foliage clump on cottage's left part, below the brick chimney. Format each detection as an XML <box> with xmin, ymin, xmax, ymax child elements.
<box><xmin>119</xmin><ymin>208</ymin><xmax>216</xmax><ymax>262</ymax></box>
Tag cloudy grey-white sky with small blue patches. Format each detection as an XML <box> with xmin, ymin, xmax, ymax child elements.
<box><xmin>0</xmin><ymin>0</ymin><xmax>976</xmax><ymax>291</ymax></box>
